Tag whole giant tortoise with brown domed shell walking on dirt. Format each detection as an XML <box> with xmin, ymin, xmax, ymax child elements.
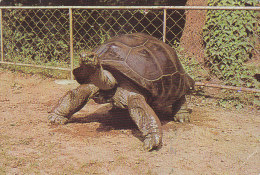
<box><xmin>48</xmin><ymin>33</ymin><xmax>194</xmax><ymax>150</ymax></box>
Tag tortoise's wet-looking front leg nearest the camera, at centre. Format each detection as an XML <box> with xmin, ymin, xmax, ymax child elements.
<box><xmin>114</xmin><ymin>88</ymin><xmax>162</xmax><ymax>151</ymax></box>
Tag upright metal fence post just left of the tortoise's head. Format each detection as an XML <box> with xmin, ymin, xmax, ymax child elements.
<box><xmin>69</xmin><ymin>8</ymin><xmax>74</xmax><ymax>80</ymax></box>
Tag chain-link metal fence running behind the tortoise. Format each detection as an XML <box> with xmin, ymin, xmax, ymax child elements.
<box><xmin>0</xmin><ymin>6</ymin><xmax>260</xmax><ymax>96</ymax></box>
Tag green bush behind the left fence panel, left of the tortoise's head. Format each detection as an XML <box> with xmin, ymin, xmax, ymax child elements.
<box><xmin>2</xmin><ymin>9</ymin><xmax>69</xmax><ymax>67</ymax></box>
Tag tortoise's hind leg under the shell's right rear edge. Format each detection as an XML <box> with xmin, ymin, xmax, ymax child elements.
<box><xmin>172</xmin><ymin>96</ymin><xmax>191</xmax><ymax>123</ymax></box>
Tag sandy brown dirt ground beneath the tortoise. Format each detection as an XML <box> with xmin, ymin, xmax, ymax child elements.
<box><xmin>0</xmin><ymin>69</ymin><xmax>260</xmax><ymax>175</ymax></box>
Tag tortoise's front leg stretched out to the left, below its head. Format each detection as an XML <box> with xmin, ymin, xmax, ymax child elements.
<box><xmin>48</xmin><ymin>84</ymin><xmax>99</xmax><ymax>124</ymax></box>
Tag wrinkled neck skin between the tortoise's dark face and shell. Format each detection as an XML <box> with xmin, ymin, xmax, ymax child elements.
<box><xmin>89</xmin><ymin>65</ymin><xmax>117</xmax><ymax>90</ymax></box>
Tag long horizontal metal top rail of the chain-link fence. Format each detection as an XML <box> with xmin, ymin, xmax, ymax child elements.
<box><xmin>0</xmin><ymin>6</ymin><xmax>260</xmax><ymax>11</ymax></box>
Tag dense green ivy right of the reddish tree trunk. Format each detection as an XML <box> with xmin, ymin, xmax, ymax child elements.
<box><xmin>203</xmin><ymin>0</ymin><xmax>260</xmax><ymax>87</ymax></box>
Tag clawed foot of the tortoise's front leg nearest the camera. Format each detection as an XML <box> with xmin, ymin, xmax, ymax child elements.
<box><xmin>144</xmin><ymin>133</ymin><xmax>162</xmax><ymax>151</ymax></box>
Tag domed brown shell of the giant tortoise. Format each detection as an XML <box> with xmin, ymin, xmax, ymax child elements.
<box><xmin>87</xmin><ymin>33</ymin><xmax>194</xmax><ymax>105</ymax></box>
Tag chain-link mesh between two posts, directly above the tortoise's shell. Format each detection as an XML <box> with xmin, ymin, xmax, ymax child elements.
<box><xmin>73</xmin><ymin>9</ymin><xmax>163</xmax><ymax>50</ymax></box>
